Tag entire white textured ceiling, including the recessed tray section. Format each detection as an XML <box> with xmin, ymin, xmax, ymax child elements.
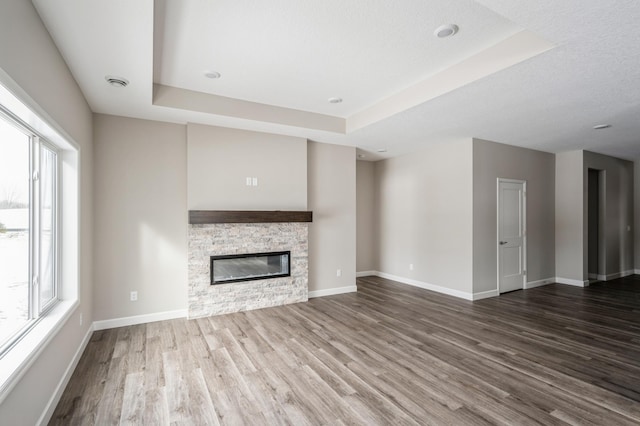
<box><xmin>33</xmin><ymin>0</ymin><xmax>640</xmax><ymax>160</ymax></box>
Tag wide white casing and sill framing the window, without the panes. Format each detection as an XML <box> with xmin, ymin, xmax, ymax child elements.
<box><xmin>0</xmin><ymin>69</ymin><xmax>81</xmax><ymax>404</ymax></box>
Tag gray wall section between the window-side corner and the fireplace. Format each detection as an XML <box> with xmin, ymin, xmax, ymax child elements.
<box><xmin>94</xmin><ymin>114</ymin><xmax>187</xmax><ymax>320</ymax></box>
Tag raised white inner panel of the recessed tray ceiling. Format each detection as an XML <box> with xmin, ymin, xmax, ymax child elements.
<box><xmin>154</xmin><ymin>0</ymin><xmax>519</xmax><ymax>117</ymax></box>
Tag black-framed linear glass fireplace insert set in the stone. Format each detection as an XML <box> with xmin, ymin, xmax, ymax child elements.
<box><xmin>211</xmin><ymin>251</ymin><xmax>291</xmax><ymax>285</ymax></box>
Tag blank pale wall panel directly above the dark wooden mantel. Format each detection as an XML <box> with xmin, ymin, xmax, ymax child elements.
<box><xmin>187</xmin><ymin>124</ymin><xmax>307</xmax><ymax>210</ymax></box>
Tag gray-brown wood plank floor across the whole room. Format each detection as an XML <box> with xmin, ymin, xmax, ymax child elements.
<box><xmin>50</xmin><ymin>275</ymin><xmax>640</xmax><ymax>425</ymax></box>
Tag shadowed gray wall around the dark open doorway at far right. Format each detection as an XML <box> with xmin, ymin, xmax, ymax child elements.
<box><xmin>581</xmin><ymin>151</ymin><xmax>634</xmax><ymax>279</ymax></box>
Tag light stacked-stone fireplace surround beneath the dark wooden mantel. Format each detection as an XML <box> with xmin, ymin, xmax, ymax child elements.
<box><xmin>188</xmin><ymin>212</ymin><xmax>311</xmax><ymax>318</ymax></box>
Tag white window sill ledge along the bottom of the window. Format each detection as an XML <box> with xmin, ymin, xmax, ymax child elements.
<box><xmin>0</xmin><ymin>300</ymin><xmax>79</xmax><ymax>404</ymax></box>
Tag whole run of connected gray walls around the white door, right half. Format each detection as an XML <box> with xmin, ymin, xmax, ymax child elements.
<box><xmin>358</xmin><ymin>139</ymin><xmax>640</xmax><ymax>293</ymax></box>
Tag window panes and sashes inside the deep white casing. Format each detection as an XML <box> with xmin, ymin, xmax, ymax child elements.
<box><xmin>0</xmin><ymin>109</ymin><xmax>59</xmax><ymax>357</ymax></box>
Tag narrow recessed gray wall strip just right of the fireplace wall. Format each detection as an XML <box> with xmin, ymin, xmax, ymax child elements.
<box><xmin>356</xmin><ymin>161</ymin><xmax>378</xmax><ymax>272</ymax></box>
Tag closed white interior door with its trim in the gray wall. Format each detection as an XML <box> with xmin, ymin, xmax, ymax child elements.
<box><xmin>498</xmin><ymin>179</ymin><xmax>527</xmax><ymax>293</ymax></box>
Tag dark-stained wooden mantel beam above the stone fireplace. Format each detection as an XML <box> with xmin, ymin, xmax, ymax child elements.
<box><xmin>189</xmin><ymin>210</ymin><xmax>313</xmax><ymax>225</ymax></box>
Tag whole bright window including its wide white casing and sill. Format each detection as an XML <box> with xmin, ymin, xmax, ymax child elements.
<box><xmin>0</xmin><ymin>76</ymin><xmax>79</xmax><ymax>404</ymax></box>
